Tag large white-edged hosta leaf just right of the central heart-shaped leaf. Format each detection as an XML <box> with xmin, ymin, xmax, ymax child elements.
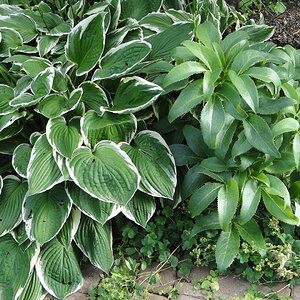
<box><xmin>120</xmin><ymin>130</ymin><xmax>177</xmax><ymax>199</ymax></box>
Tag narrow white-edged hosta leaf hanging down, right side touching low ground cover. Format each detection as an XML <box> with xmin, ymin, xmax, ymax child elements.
<box><xmin>75</xmin><ymin>216</ymin><xmax>114</xmax><ymax>273</ymax></box>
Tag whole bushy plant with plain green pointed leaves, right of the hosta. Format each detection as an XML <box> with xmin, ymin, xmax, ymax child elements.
<box><xmin>162</xmin><ymin>21</ymin><xmax>300</xmax><ymax>271</ymax></box>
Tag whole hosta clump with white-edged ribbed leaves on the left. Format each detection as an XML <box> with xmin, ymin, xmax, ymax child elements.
<box><xmin>0</xmin><ymin>0</ymin><xmax>209</xmax><ymax>300</ymax></box>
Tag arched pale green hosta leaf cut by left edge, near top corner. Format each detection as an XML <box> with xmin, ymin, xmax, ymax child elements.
<box><xmin>0</xmin><ymin>13</ymin><xmax>37</xmax><ymax>43</ymax></box>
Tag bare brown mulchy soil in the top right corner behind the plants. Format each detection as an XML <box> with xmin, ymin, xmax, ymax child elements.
<box><xmin>226</xmin><ymin>0</ymin><xmax>300</xmax><ymax>49</ymax></box>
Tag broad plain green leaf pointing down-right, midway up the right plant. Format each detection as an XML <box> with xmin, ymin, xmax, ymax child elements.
<box><xmin>243</xmin><ymin>114</ymin><xmax>280</xmax><ymax>157</ymax></box>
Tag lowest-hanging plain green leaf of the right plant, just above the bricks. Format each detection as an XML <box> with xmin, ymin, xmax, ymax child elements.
<box><xmin>216</xmin><ymin>227</ymin><xmax>240</xmax><ymax>272</ymax></box>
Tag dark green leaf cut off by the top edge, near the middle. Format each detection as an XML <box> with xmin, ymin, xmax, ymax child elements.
<box><xmin>120</xmin><ymin>0</ymin><xmax>162</xmax><ymax>20</ymax></box>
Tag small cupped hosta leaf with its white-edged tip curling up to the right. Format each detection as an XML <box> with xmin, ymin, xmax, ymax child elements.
<box><xmin>35</xmin><ymin>89</ymin><xmax>82</xmax><ymax>118</ymax></box>
